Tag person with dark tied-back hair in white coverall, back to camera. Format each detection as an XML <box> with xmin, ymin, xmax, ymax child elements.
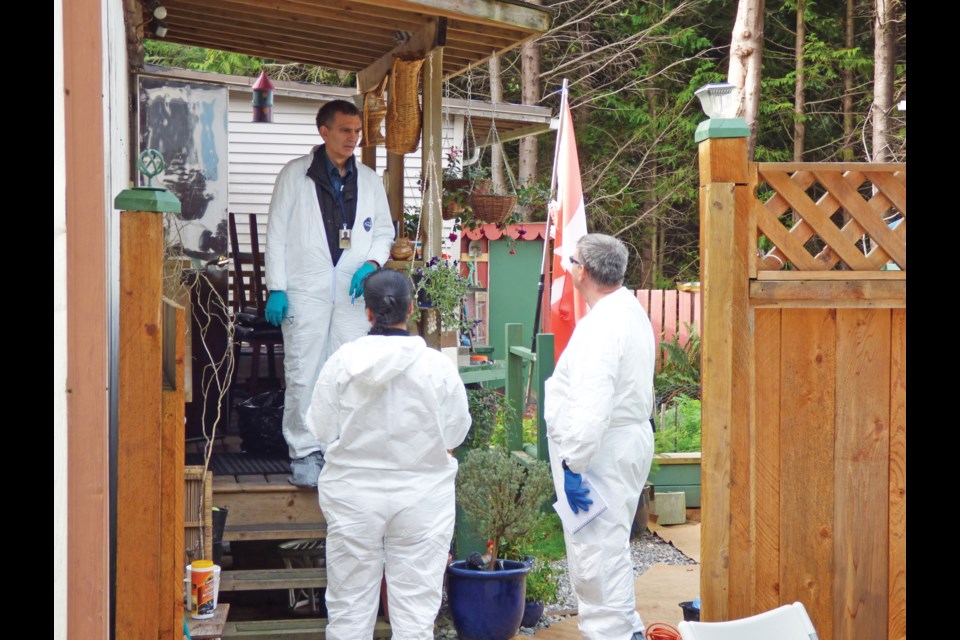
<box><xmin>307</xmin><ymin>269</ymin><xmax>470</xmax><ymax>640</ymax></box>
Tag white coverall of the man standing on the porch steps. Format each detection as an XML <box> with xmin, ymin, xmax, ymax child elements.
<box><xmin>265</xmin><ymin>147</ymin><xmax>394</xmax><ymax>458</ymax></box>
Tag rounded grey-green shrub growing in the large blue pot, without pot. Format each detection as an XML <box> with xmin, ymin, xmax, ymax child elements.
<box><xmin>457</xmin><ymin>448</ymin><xmax>553</xmax><ymax>566</ymax></box>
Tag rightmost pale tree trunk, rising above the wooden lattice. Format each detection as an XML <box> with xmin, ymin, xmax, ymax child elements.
<box><xmin>870</xmin><ymin>0</ymin><xmax>897</xmax><ymax>162</ymax></box>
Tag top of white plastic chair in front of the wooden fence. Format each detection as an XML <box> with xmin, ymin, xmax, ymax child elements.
<box><xmin>677</xmin><ymin>602</ymin><xmax>818</xmax><ymax>640</ymax></box>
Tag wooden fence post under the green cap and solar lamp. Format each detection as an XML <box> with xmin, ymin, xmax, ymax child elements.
<box><xmin>699</xmin><ymin>138</ymin><xmax>752</xmax><ymax>620</ymax></box>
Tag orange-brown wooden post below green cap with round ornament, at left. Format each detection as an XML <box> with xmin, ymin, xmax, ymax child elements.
<box><xmin>116</xmin><ymin>211</ymin><xmax>166</xmax><ymax>640</ymax></box>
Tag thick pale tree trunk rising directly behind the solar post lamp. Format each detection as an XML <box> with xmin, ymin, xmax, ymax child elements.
<box><xmin>727</xmin><ymin>0</ymin><xmax>764</xmax><ymax>158</ymax></box>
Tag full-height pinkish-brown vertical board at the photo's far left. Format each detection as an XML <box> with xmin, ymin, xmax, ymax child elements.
<box><xmin>64</xmin><ymin>0</ymin><xmax>111</xmax><ymax>638</ymax></box>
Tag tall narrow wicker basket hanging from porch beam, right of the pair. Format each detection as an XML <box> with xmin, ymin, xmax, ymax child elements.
<box><xmin>386</xmin><ymin>52</ymin><xmax>424</xmax><ymax>154</ymax></box>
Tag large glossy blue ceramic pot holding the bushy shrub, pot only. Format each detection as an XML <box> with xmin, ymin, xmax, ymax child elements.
<box><xmin>447</xmin><ymin>560</ymin><xmax>530</xmax><ymax>640</ymax></box>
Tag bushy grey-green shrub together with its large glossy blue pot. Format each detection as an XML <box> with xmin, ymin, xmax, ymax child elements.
<box><xmin>447</xmin><ymin>448</ymin><xmax>553</xmax><ymax>640</ymax></box>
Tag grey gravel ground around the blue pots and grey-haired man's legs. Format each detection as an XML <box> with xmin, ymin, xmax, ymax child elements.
<box><xmin>434</xmin><ymin>531</ymin><xmax>696</xmax><ymax>640</ymax></box>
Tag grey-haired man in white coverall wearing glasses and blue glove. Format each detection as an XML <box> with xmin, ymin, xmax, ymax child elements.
<box><xmin>544</xmin><ymin>233</ymin><xmax>654</xmax><ymax>640</ymax></box>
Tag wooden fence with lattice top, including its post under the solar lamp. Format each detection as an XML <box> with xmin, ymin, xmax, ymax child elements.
<box><xmin>700</xmin><ymin>138</ymin><xmax>907</xmax><ymax>640</ymax></box>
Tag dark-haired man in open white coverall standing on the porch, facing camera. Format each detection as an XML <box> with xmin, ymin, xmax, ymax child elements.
<box><xmin>265</xmin><ymin>100</ymin><xmax>394</xmax><ymax>487</ymax></box>
